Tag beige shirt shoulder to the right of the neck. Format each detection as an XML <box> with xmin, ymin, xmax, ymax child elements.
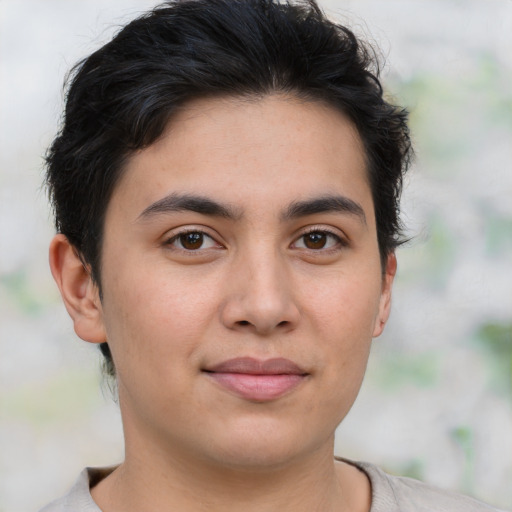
<box><xmin>354</xmin><ymin>462</ymin><xmax>503</xmax><ymax>512</ymax></box>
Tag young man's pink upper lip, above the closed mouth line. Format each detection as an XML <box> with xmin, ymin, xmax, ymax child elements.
<box><xmin>205</xmin><ymin>357</ymin><xmax>307</xmax><ymax>375</ymax></box>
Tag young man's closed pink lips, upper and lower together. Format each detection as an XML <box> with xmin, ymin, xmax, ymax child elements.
<box><xmin>205</xmin><ymin>357</ymin><xmax>308</xmax><ymax>402</ymax></box>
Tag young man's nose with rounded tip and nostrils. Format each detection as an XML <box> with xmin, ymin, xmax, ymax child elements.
<box><xmin>221</xmin><ymin>252</ymin><xmax>300</xmax><ymax>336</ymax></box>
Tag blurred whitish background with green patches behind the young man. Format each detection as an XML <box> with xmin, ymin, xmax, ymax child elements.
<box><xmin>0</xmin><ymin>0</ymin><xmax>512</xmax><ymax>512</ymax></box>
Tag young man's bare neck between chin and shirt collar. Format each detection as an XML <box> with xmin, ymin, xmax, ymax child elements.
<box><xmin>92</xmin><ymin>440</ymin><xmax>369</xmax><ymax>512</ymax></box>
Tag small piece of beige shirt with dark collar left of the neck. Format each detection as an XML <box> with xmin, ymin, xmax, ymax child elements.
<box><xmin>39</xmin><ymin>467</ymin><xmax>114</xmax><ymax>512</ymax></box>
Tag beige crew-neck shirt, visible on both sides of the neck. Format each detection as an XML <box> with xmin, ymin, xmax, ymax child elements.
<box><xmin>40</xmin><ymin>461</ymin><xmax>505</xmax><ymax>512</ymax></box>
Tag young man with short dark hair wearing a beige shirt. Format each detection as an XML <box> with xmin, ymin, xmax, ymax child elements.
<box><xmin>39</xmin><ymin>0</ymin><xmax>504</xmax><ymax>512</ymax></box>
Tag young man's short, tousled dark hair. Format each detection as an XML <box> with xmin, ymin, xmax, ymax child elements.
<box><xmin>46</xmin><ymin>0</ymin><xmax>411</xmax><ymax>374</ymax></box>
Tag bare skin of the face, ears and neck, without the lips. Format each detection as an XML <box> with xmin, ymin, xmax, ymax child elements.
<box><xmin>50</xmin><ymin>95</ymin><xmax>396</xmax><ymax>512</ymax></box>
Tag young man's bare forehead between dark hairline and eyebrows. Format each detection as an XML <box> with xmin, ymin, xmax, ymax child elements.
<box><xmin>107</xmin><ymin>94</ymin><xmax>373</xmax><ymax>223</ymax></box>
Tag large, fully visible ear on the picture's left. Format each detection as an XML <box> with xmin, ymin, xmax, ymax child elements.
<box><xmin>50</xmin><ymin>234</ymin><xmax>106</xmax><ymax>343</ymax></box>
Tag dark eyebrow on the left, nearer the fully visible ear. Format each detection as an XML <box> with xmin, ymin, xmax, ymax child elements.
<box><xmin>138</xmin><ymin>193</ymin><xmax>241</xmax><ymax>220</ymax></box>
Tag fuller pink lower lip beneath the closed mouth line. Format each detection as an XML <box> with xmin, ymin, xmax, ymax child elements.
<box><xmin>208</xmin><ymin>372</ymin><xmax>306</xmax><ymax>402</ymax></box>
